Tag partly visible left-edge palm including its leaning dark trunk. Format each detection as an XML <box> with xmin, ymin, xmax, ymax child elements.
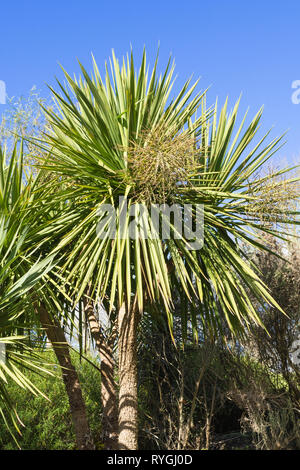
<box><xmin>0</xmin><ymin>142</ymin><xmax>93</xmax><ymax>449</ymax></box>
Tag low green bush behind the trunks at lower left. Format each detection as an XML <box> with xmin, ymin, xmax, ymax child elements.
<box><xmin>0</xmin><ymin>351</ymin><xmax>101</xmax><ymax>450</ymax></box>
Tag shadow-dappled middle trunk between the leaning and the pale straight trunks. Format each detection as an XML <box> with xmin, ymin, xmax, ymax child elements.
<box><xmin>84</xmin><ymin>297</ymin><xmax>118</xmax><ymax>450</ymax></box>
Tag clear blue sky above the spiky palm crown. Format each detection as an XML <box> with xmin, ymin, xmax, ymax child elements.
<box><xmin>0</xmin><ymin>0</ymin><xmax>300</xmax><ymax>166</ymax></box>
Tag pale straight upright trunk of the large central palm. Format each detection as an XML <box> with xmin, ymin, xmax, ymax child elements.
<box><xmin>118</xmin><ymin>300</ymin><xmax>139</xmax><ymax>450</ymax></box>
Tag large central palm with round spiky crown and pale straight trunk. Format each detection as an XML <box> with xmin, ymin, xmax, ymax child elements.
<box><xmin>41</xmin><ymin>51</ymin><xmax>298</xmax><ymax>449</ymax></box>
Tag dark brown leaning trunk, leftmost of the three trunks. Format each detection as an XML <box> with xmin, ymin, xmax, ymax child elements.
<box><xmin>38</xmin><ymin>305</ymin><xmax>95</xmax><ymax>450</ymax></box>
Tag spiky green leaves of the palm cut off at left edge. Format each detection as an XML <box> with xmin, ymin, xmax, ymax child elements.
<box><xmin>0</xmin><ymin>144</ymin><xmax>54</xmax><ymax>442</ymax></box>
